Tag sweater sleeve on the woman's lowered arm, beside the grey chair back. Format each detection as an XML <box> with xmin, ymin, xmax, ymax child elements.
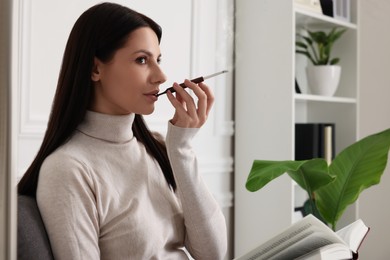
<box><xmin>37</xmin><ymin>153</ymin><xmax>100</xmax><ymax>260</ymax></box>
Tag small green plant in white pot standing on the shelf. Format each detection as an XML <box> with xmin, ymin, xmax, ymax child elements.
<box><xmin>295</xmin><ymin>27</ymin><xmax>346</xmax><ymax>96</ymax></box>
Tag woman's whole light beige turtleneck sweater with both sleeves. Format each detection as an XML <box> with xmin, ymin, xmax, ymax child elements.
<box><xmin>37</xmin><ymin>111</ymin><xmax>227</xmax><ymax>260</ymax></box>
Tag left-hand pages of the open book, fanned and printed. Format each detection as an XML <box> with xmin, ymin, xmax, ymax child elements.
<box><xmin>236</xmin><ymin>215</ymin><xmax>345</xmax><ymax>260</ymax></box>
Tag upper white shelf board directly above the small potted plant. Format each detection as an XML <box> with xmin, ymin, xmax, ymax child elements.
<box><xmin>294</xmin><ymin>7</ymin><xmax>357</xmax><ymax>29</ymax></box>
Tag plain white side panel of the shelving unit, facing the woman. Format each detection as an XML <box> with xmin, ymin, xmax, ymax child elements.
<box><xmin>234</xmin><ymin>0</ymin><xmax>294</xmax><ymax>257</ymax></box>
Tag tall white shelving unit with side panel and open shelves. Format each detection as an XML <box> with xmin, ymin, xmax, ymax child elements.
<box><xmin>234</xmin><ymin>0</ymin><xmax>359</xmax><ymax>256</ymax></box>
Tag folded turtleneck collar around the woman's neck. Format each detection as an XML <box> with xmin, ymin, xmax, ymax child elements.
<box><xmin>77</xmin><ymin>111</ymin><xmax>135</xmax><ymax>143</ymax></box>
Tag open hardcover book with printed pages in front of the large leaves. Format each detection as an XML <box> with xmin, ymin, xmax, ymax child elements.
<box><xmin>236</xmin><ymin>215</ymin><xmax>369</xmax><ymax>260</ymax></box>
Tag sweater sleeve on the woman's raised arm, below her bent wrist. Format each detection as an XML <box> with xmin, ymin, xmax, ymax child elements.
<box><xmin>166</xmin><ymin>123</ymin><xmax>227</xmax><ymax>260</ymax></box>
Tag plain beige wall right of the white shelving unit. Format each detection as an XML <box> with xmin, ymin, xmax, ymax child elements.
<box><xmin>358</xmin><ymin>0</ymin><xmax>390</xmax><ymax>259</ymax></box>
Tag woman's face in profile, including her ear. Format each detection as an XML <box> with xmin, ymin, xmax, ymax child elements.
<box><xmin>90</xmin><ymin>27</ymin><xmax>166</xmax><ymax>115</ymax></box>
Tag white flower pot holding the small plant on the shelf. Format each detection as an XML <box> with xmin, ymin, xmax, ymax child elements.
<box><xmin>306</xmin><ymin>65</ymin><xmax>341</xmax><ymax>97</ymax></box>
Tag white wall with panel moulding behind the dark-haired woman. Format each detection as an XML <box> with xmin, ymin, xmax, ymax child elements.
<box><xmin>13</xmin><ymin>0</ymin><xmax>234</xmax><ymax>258</ymax></box>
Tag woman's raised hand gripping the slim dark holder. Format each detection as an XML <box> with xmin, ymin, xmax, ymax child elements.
<box><xmin>167</xmin><ymin>79</ymin><xmax>214</xmax><ymax>128</ymax></box>
